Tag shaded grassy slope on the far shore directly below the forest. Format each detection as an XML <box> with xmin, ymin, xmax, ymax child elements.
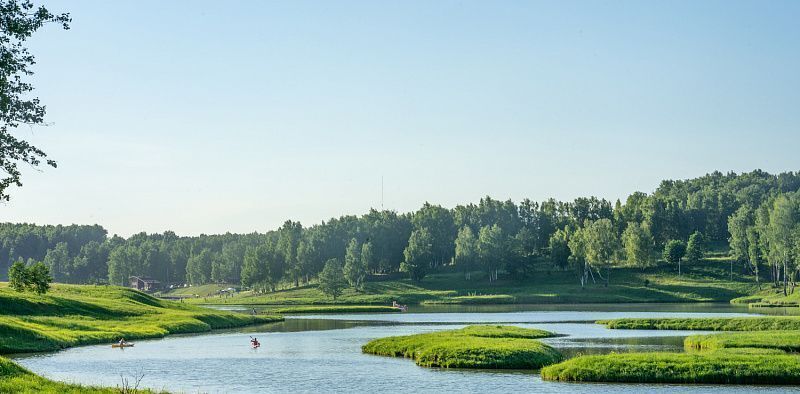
<box><xmin>173</xmin><ymin>261</ymin><xmax>756</xmax><ymax>305</ymax></box>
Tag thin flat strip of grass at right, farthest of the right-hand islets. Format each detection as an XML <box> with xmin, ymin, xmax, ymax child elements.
<box><xmin>597</xmin><ymin>316</ymin><xmax>800</xmax><ymax>331</ymax></box>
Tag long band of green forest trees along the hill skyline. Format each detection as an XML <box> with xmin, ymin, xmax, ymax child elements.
<box><xmin>0</xmin><ymin>170</ymin><xmax>800</xmax><ymax>291</ymax></box>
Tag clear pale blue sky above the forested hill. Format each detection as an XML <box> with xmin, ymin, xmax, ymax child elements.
<box><xmin>0</xmin><ymin>0</ymin><xmax>800</xmax><ymax>235</ymax></box>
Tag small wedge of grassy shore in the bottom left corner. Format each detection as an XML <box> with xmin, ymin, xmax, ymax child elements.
<box><xmin>0</xmin><ymin>357</ymin><xmax>158</xmax><ymax>394</ymax></box>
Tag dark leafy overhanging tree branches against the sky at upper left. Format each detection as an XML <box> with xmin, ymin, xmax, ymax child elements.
<box><xmin>0</xmin><ymin>0</ymin><xmax>71</xmax><ymax>200</ymax></box>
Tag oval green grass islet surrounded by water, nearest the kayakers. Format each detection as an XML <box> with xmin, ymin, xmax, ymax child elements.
<box><xmin>361</xmin><ymin>325</ymin><xmax>562</xmax><ymax>369</ymax></box>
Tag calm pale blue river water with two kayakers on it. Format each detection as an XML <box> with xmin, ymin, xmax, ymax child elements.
<box><xmin>13</xmin><ymin>304</ymin><xmax>795</xmax><ymax>394</ymax></box>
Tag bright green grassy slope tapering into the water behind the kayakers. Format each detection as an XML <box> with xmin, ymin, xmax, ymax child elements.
<box><xmin>0</xmin><ymin>284</ymin><xmax>281</xmax><ymax>354</ymax></box>
